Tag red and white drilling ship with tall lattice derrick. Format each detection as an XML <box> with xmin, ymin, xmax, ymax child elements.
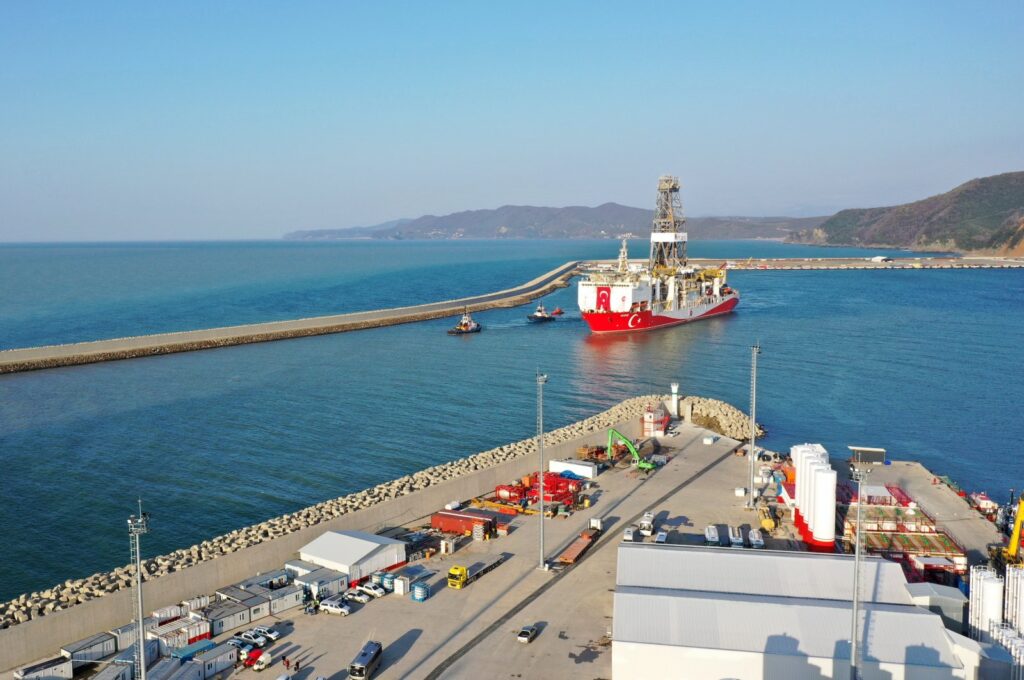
<box><xmin>578</xmin><ymin>175</ymin><xmax>739</xmax><ymax>333</ymax></box>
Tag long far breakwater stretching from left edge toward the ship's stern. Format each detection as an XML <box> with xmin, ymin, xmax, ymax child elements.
<box><xmin>0</xmin><ymin>262</ymin><xmax>577</xmax><ymax>374</ymax></box>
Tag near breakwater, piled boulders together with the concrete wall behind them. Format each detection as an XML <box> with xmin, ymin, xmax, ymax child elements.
<box><xmin>0</xmin><ymin>394</ymin><xmax>764</xmax><ymax>671</ymax></box>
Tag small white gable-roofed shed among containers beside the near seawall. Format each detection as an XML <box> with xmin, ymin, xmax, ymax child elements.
<box><xmin>299</xmin><ymin>532</ymin><xmax>406</xmax><ymax>583</ymax></box>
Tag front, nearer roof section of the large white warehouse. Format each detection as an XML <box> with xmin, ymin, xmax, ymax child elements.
<box><xmin>612</xmin><ymin>586</ymin><xmax>961</xmax><ymax>669</ymax></box>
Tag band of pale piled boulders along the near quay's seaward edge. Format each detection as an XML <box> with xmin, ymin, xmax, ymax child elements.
<box><xmin>0</xmin><ymin>395</ymin><xmax>761</xmax><ymax>629</ymax></box>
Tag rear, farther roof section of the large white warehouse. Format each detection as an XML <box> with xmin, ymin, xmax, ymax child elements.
<box><xmin>615</xmin><ymin>543</ymin><xmax>911</xmax><ymax>604</ymax></box>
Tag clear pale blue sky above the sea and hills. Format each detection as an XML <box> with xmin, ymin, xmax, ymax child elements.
<box><xmin>0</xmin><ymin>0</ymin><xmax>1024</xmax><ymax>241</ymax></box>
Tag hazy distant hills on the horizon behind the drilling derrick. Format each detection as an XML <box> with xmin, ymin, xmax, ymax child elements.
<box><xmin>285</xmin><ymin>203</ymin><xmax>824</xmax><ymax>240</ymax></box>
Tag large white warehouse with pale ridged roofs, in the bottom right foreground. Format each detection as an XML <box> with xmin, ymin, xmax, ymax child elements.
<box><xmin>611</xmin><ymin>544</ymin><xmax>1009</xmax><ymax>680</ymax></box>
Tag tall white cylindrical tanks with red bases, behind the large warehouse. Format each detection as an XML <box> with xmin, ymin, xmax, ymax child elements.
<box><xmin>790</xmin><ymin>443</ymin><xmax>836</xmax><ymax>549</ymax></box>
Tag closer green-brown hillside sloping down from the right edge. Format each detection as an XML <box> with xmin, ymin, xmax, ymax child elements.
<box><xmin>790</xmin><ymin>172</ymin><xmax>1024</xmax><ymax>254</ymax></box>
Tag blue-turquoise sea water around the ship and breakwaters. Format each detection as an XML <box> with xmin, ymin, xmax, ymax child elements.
<box><xmin>0</xmin><ymin>242</ymin><xmax>1024</xmax><ymax>598</ymax></box>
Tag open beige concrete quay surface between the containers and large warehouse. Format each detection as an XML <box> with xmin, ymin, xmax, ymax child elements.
<box><xmin>209</xmin><ymin>426</ymin><xmax>788</xmax><ymax>680</ymax></box>
